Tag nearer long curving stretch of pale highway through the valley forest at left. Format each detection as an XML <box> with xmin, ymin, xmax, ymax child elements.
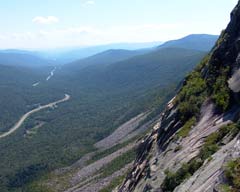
<box><xmin>0</xmin><ymin>94</ymin><xmax>70</xmax><ymax>138</ymax></box>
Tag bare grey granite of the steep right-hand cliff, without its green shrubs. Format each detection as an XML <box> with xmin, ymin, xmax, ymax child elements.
<box><xmin>118</xmin><ymin>1</ymin><xmax>240</xmax><ymax>192</ymax></box>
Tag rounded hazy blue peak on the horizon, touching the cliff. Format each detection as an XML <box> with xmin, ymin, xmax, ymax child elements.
<box><xmin>158</xmin><ymin>34</ymin><xmax>218</xmax><ymax>51</ymax></box>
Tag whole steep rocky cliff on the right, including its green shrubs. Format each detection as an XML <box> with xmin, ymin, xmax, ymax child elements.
<box><xmin>118</xmin><ymin>2</ymin><xmax>240</xmax><ymax>192</ymax></box>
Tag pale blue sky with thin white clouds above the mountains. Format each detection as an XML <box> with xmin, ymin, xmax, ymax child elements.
<box><xmin>0</xmin><ymin>0</ymin><xmax>238</xmax><ymax>49</ymax></box>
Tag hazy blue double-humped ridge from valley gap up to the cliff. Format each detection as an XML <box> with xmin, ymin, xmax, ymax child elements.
<box><xmin>63</xmin><ymin>34</ymin><xmax>218</xmax><ymax>68</ymax></box>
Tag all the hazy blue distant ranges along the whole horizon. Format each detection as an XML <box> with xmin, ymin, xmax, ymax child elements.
<box><xmin>0</xmin><ymin>34</ymin><xmax>218</xmax><ymax>67</ymax></box>
